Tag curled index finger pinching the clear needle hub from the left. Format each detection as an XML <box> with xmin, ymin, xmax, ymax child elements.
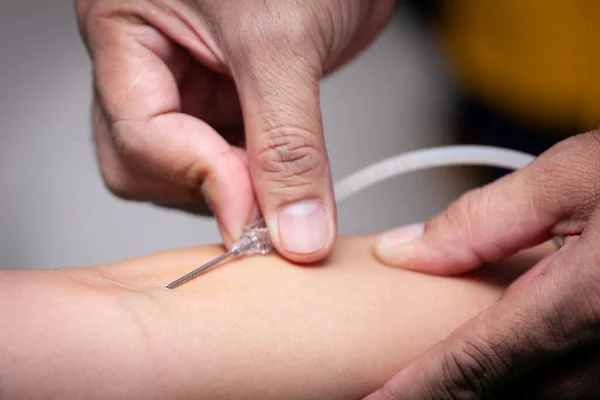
<box><xmin>90</xmin><ymin>14</ymin><xmax>254</xmax><ymax>244</ymax></box>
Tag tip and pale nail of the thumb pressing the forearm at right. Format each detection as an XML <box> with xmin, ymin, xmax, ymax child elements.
<box><xmin>375</xmin><ymin>224</ymin><xmax>425</xmax><ymax>265</ymax></box>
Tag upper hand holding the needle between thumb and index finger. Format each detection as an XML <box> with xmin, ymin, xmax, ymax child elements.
<box><xmin>77</xmin><ymin>0</ymin><xmax>395</xmax><ymax>262</ymax></box>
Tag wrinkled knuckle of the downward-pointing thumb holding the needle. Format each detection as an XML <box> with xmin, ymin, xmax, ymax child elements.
<box><xmin>254</xmin><ymin>127</ymin><xmax>326</xmax><ymax>195</ymax></box>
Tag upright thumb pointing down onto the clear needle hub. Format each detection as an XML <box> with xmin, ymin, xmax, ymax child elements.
<box><xmin>232</xmin><ymin>21</ymin><xmax>337</xmax><ymax>262</ymax></box>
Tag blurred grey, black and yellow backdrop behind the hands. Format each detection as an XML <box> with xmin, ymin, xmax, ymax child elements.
<box><xmin>0</xmin><ymin>0</ymin><xmax>584</xmax><ymax>269</ymax></box>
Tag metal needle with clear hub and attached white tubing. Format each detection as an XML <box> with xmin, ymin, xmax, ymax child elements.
<box><xmin>166</xmin><ymin>145</ymin><xmax>535</xmax><ymax>289</ymax></box>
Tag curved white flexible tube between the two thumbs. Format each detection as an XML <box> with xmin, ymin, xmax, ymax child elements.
<box><xmin>334</xmin><ymin>146</ymin><xmax>535</xmax><ymax>203</ymax></box>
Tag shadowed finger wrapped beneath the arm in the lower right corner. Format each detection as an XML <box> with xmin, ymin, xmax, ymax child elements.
<box><xmin>367</xmin><ymin>209</ymin><xmax>600</xmax><ymax>400</ymax></box>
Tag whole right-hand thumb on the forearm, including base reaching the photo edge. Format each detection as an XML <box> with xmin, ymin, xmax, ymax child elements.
<box><xmin>376</xmin><ymin>133</ymin><xmax>600</xmax><ymax>274</ymax></box>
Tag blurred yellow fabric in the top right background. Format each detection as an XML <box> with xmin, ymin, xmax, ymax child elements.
<box><xmin>439</xmin><ymin>0</ymin><xmax>600</xmax><ymax>133</ymax></box>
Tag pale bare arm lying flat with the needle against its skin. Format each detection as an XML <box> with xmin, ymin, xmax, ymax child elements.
<box><xmin>0</xmin><ymin>236</ymin><xmax>548</xmax><ymax>400</ymax></box>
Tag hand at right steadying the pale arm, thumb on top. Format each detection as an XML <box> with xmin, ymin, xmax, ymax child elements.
<box><xmin>367</xmin><ymin>132</ymin><xmax>600</xmax><ymax>400</ymax></box>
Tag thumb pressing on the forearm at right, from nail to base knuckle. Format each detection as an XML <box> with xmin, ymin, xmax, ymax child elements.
<box><xmin>375</xmin><ymin>156</ymin><xmax>562</xmax><ymax>274</ymax></box>
